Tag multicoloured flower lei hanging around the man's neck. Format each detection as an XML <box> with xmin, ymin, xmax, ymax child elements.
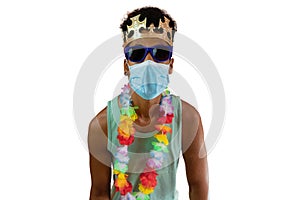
<box><xmin>114</xmin><ymin>84</ymin><xmax>174</xmax><ymax>200</ymax></box>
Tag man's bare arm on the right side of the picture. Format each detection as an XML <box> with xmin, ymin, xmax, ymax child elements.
<box><xmin>182</xmin><ymin>101</ymin><xmax>209</xmax><ymax>200</ymax></box>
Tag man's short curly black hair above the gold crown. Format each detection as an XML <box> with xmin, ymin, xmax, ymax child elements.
<box><xmin>120</xmin><ymin>6</ymin><xmax>177</xmax><ymax>40</ymax></box>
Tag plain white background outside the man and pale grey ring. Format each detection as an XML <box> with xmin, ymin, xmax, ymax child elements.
<box><xmin>0</xmin><ymin>0</ymin><xmax>300</xmax><ymax>200</ymax></box>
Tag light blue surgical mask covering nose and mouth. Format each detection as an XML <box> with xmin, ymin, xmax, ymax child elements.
<box><xmin>128</xmin><ymin>60</ymin><xmax>169</xmax><ymax>100</ymax></box>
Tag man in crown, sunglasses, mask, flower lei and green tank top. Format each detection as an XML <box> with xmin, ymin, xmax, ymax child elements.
<box><xmin>88</xmin><ymin>7</ymin><xmax>208</xmax><ymax>200</ymax></box>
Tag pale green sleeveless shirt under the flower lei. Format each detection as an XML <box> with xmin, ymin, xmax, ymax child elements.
<box><xmin>107</xmin><ymin>95</ymin><xmax>182</xmax><ymax>200</ymax></box>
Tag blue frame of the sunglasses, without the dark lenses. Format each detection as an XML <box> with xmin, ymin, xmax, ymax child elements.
<box><xmin>124</xmin><ymin>45</ymin><xmax>173</xmax><ymax>62</ymax></box>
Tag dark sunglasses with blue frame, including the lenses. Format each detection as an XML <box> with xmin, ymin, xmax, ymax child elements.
<box><xmin>124</xmin><ymin>45</ymin><xmax>173</xmax><ymax>62</ymax></box>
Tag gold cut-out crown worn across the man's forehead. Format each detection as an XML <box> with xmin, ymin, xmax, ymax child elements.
<box><xmin>123</xmin><ymin>14</ymin><xmax>173</xmax><ymax>47</ymax></box>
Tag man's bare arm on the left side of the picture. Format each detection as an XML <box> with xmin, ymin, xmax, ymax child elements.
<box><xmin>88</xmin><ymin>108</ymin><xmax>111</xmax><ymax>200</ymax></box>
